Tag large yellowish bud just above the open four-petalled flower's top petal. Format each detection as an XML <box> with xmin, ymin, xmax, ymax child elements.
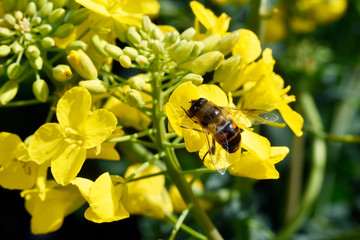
<box><xmin>67</xmin><ymin>49</ymin><xmax>98</xmax><ymax>79</ymax></box>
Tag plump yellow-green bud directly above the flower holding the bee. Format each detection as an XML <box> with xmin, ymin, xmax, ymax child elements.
<box><xmin>190</xmin><ymin>51</ymin><xmax>224</xmax><ymax>75</ymax></box>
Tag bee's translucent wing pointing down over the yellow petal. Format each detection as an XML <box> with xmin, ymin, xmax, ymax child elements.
<box><xmin>203</xmin><ymin>128</ymin><xmax>229</xmax><ymax>175</ymax></box>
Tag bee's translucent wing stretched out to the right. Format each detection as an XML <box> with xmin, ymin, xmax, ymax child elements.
<box><xmin>221</xmin><ymin>107</ymin><xmax>279</xmax><ymax>125</ymax></box>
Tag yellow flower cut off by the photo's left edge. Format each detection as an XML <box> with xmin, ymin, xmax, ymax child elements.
<box><xmin>0</xmin><ymin>132</ymin><xmax>38</xmax><ymax>189</ymax></box>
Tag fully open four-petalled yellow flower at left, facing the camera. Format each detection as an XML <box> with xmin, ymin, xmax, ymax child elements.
<box><xmin>29</xmin><ymin>87</ymin><xmax>117</xmax><ymax>185</ymax></box>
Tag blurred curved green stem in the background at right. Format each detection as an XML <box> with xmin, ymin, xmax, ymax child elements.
<box><xmin>276</xmin><ymin>91</ymin><xmax>326</xmax><ymax>240</ymax></box>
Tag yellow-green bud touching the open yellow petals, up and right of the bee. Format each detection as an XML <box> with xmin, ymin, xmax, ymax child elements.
<box><xmin>214</xmin><ymin>55</ymin><xmax>242</xmax><ymax>82</ymax></box>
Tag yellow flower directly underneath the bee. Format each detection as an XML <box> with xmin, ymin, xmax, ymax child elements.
<box><xmin>164</xmin><ymin>82</ymin><xmax>278</xmax><ymax>177</ymax></box>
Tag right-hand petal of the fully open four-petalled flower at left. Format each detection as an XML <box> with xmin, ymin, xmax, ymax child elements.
<box><xmin>80</xmin><ymin>109</ymin><xmax>117</xmax><ymax>149</ymax></box>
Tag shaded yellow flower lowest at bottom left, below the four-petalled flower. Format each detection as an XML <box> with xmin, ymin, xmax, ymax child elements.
<box><xmin>21</xmin><ymin>180</ymin><xmax>85</xmax><ymax>234</ymax></box>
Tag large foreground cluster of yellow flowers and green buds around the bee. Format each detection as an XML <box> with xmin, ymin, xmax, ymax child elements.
<box><xmin>0</xmin><ymin>0</ymin><xmax>303</xmax><ymax>237</ymax></box>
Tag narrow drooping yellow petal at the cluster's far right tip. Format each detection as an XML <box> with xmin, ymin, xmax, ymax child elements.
<box><xmin>277</xmin><ymin>102</ymin><xmax>304</xmax><ymax>137</ymax></box>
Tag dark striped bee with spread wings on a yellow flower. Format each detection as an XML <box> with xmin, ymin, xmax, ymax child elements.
<box><xmin>181</xmin><ymin>98</ymin><xmax>278</xmax><ymax>175</ymax></box>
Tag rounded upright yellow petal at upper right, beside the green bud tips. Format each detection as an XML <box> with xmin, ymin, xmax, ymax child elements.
<box><xmin>232</xmin><ymin>29</ymin><xmax>261</xmax><ymax>64</ymax></box>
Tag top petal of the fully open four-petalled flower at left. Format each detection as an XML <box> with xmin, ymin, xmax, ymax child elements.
<box><xmin>56</xmin><ymin>87</ymin><xmax>91</xmax><ymax>129</ymax></box>
